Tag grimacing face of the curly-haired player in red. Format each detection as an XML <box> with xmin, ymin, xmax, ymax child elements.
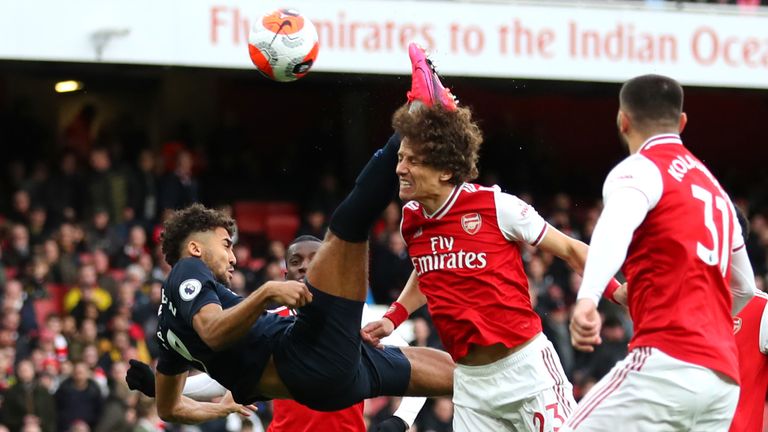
<box><xmin>396</xmin><ymin>137</ymin><xmax>450</xmax><ymax>204</ymax></box>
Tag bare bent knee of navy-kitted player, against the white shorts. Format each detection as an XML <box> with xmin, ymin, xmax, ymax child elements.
<box><xmin>401</xmin><ymin>347</ymin><xmax>456</xmax><ymax>396</ymax></box>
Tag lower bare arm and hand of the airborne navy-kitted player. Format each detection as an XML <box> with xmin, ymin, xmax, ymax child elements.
<box><xmin>155</xmin><ymin>372</ymin><xmax>256</xmax><ymax>424</ymax></box>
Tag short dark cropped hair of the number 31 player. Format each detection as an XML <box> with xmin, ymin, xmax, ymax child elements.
<box><xmin>619</xmin><ymin>74</ymin><xmax>683</xmax><ymax>129</ymax></box>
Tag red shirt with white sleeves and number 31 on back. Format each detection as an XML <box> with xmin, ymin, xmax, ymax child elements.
<box><xmin>616</xmin><ymin>135</ymin><xmax>743</xmax><ymax>382</ymax></box>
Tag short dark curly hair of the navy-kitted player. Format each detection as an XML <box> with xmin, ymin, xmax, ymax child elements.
<box><xmin>160</xmin><ymin>204</ymin><xmax>236</xmax><ymax>265</ymax></box>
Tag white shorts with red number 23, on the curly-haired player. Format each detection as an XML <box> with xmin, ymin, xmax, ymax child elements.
<box><xmin>453</xmin><ymin>334</ymin><xmax>576</xmax><ymax>432</ymax></box>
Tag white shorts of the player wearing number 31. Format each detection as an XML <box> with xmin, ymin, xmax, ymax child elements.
<box><xmin>560</xmin><ymin>347</ymin><xmax>739</xmax><ymax>432</ymax></box>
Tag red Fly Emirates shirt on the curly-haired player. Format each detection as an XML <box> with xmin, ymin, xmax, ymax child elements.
<box><xmin>401</xmin><ymin>183</ymin><xmax>548</xmax><ymax>360</ymax></box>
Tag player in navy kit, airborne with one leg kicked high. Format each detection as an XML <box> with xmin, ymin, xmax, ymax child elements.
<box><xmin>142</xmin><ymin>52</ymin><xmax>454</xmax><ymax>423</ymax></box>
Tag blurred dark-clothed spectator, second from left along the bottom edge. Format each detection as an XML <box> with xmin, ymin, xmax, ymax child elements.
<box><xmin>55</xmin><ymin>362</ymin><xmax>103</xmax><ymax>432</ymax></box>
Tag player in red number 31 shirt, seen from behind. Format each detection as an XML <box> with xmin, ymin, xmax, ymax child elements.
<box><xmin>563</xmin><ymin>75</ymin><xmax>754</xmax><ymax>431</ymax></box>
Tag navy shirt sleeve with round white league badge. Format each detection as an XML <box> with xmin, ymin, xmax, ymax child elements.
<box><xmin>168</xmin><ymin>258</ymin><xmax>221</xmax><ymax>326</ymax></box>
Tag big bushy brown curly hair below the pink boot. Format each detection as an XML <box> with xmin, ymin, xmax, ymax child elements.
<box><xmin>392</xmin><ymin>104</ymin><xmax>483</xmax><ymax>185</ymax></box>
